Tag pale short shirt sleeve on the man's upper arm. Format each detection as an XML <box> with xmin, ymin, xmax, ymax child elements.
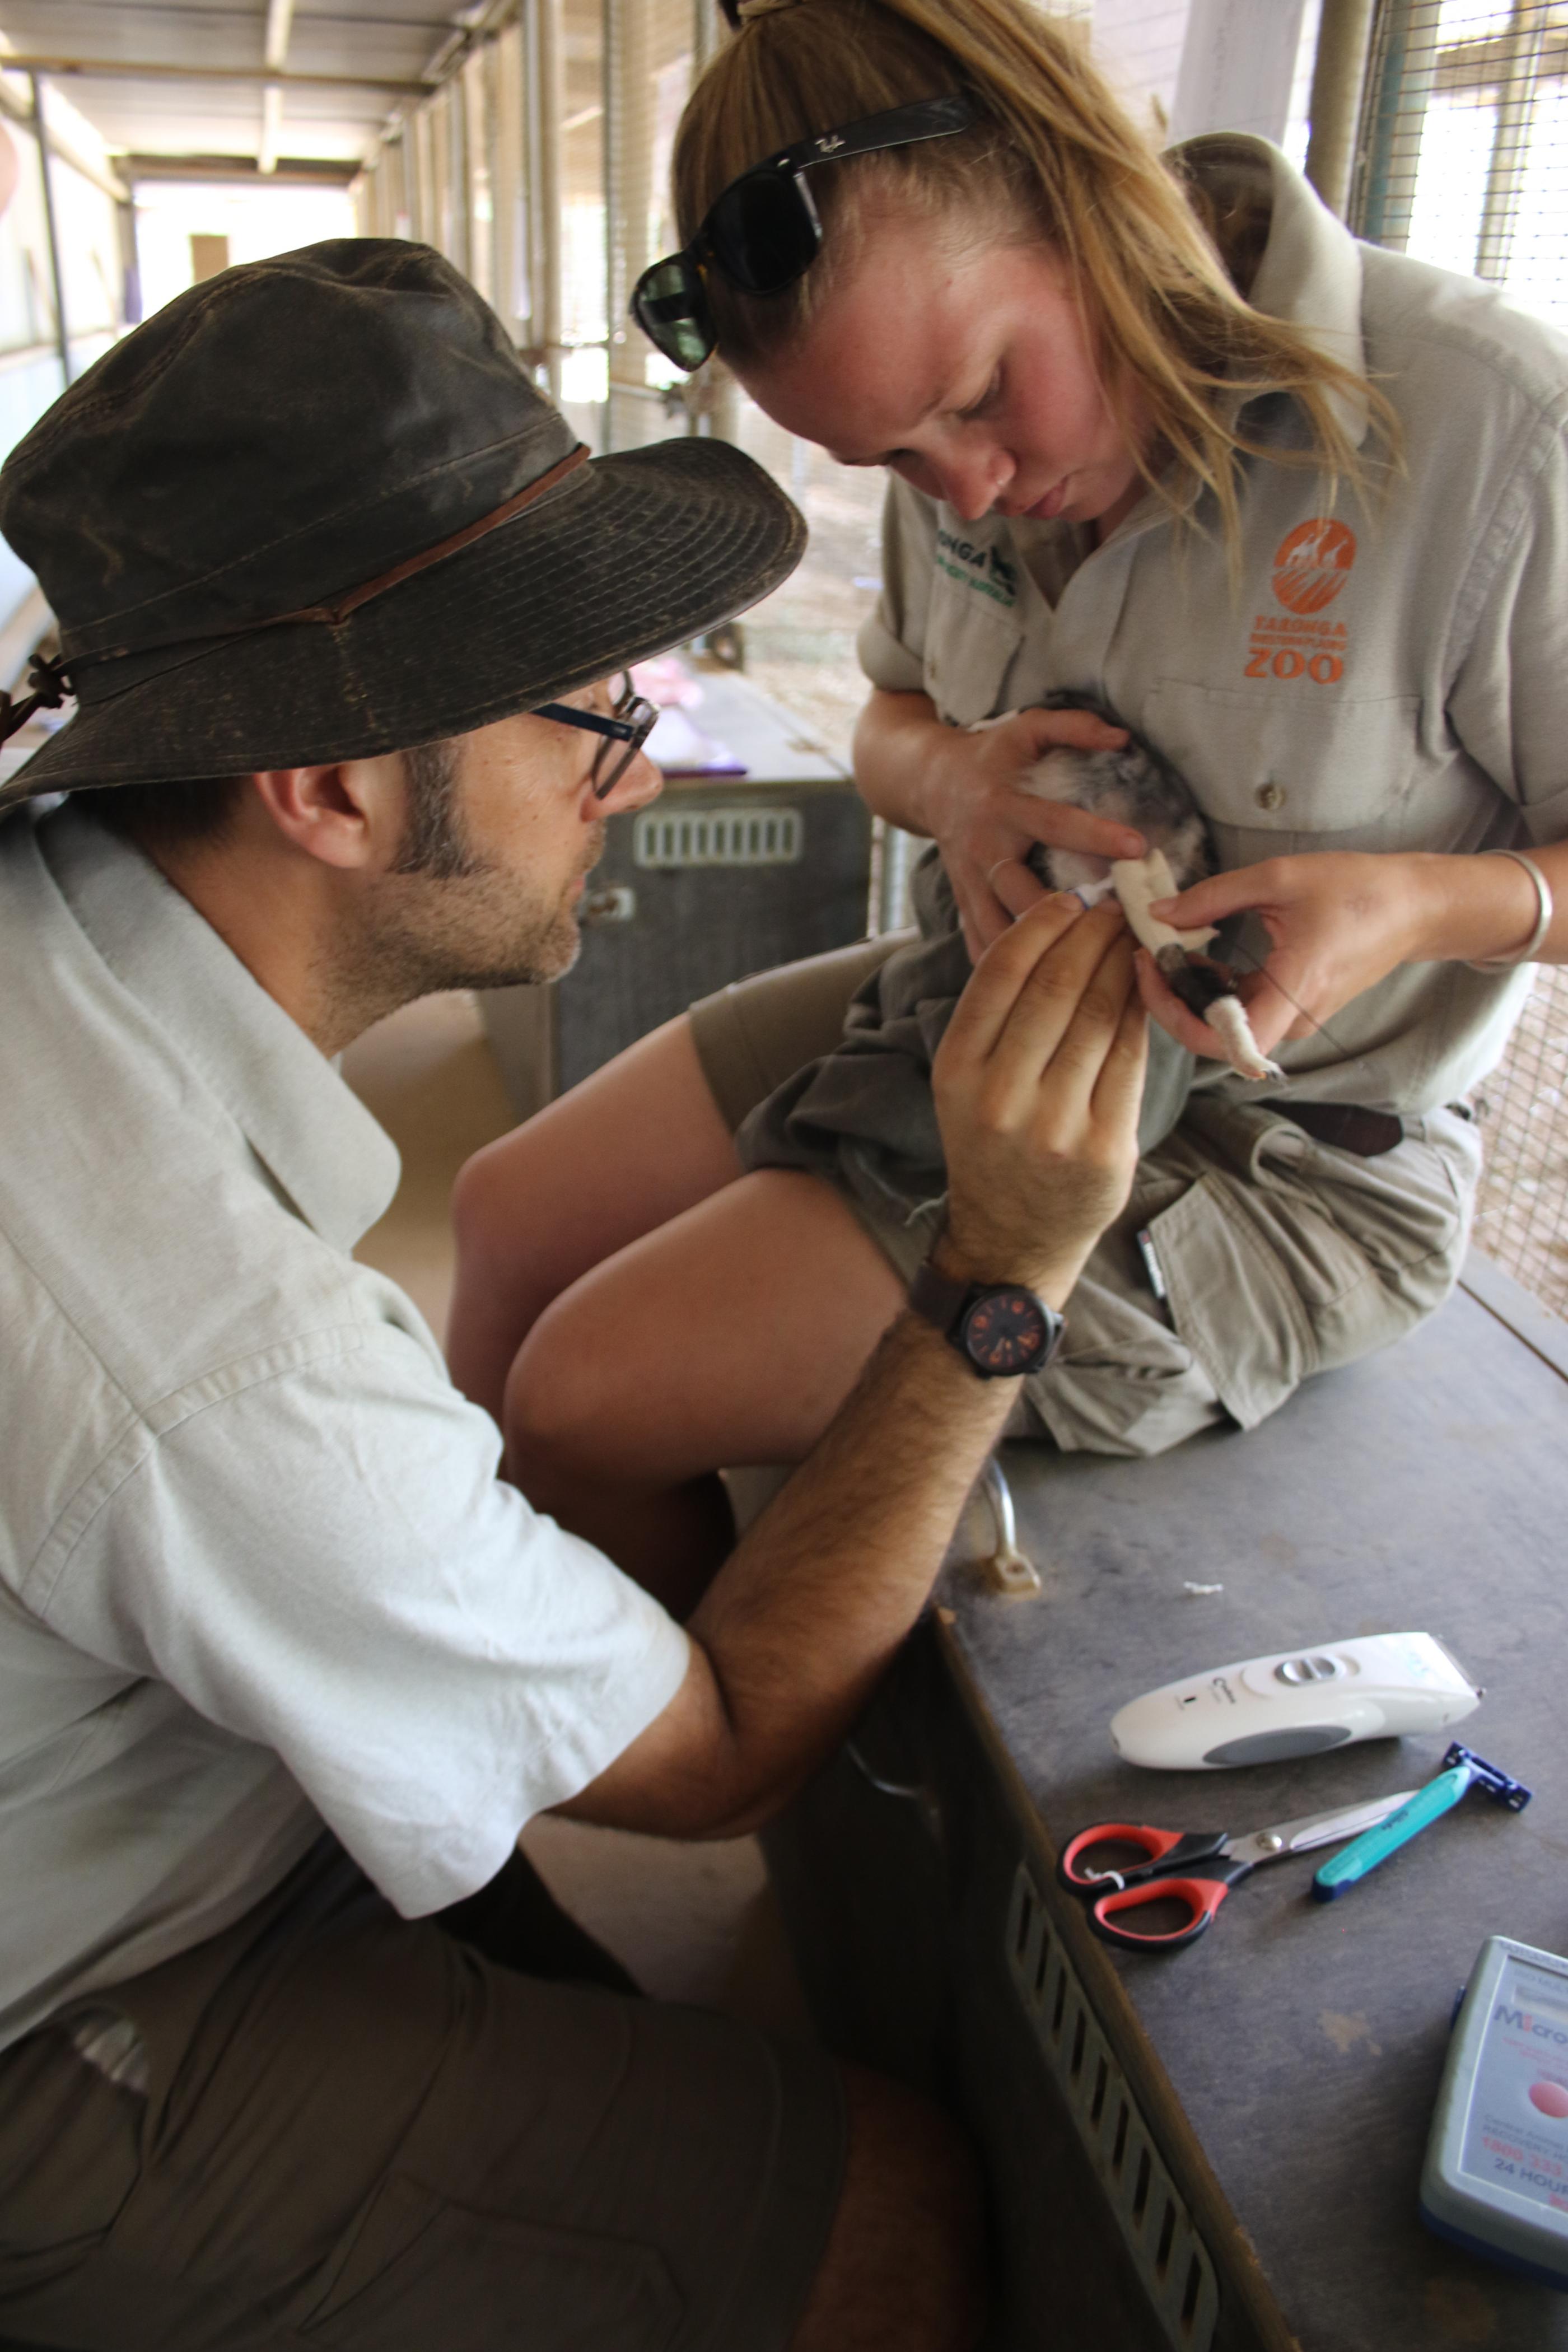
<box><xmin>47</xmin><ymin>1324</ymin><xmax>689</xmax><ymax>1917</ymax></box>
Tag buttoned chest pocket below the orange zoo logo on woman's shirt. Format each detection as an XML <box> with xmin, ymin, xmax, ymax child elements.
<box><xmin>1142</xmin><ymin>678</ymin><xmax>1420</xmax><ymax>866</ymax></box>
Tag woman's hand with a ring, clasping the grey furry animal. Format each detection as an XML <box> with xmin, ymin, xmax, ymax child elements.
<box><xmin>928</xmin><ymin>710</ymin><xmax>1145</xmax><ymax>960</ymax></box>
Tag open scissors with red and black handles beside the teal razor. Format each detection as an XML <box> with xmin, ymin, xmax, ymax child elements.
<box><xmin>1058</xmin><ymin>1790</ymin><xmax>1411</xmax><ymax>1952</ymax></box>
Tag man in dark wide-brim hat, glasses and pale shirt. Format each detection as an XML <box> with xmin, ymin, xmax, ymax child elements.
<box><xmin>0</xmin><ymin>240</ymin><xmax>1140</xmax><ymax>2352</ymax></box>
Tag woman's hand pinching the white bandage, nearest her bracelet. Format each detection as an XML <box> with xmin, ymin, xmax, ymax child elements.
<box><xmin>1138</xmin><ymin>851</ymin><xmax>1432</xmax><ymax>1061</ymax></box>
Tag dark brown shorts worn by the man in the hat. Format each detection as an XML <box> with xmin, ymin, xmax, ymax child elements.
<box><xmin>0</xmin><ymin>1839</ymin><xmax>844</xmax><ymax>2352</ymax></box>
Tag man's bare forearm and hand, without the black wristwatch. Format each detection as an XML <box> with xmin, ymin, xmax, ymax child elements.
<box><xmin>571</xmin><ymin>898</ymin><xmax>1145</xmax><ymax>1837</ymax></box>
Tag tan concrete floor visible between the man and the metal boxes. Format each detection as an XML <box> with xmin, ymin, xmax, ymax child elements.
<box><xmin>343</xmin><ymin>995</ymin><xmax>811</xmax><ymax>2039</ymax></box>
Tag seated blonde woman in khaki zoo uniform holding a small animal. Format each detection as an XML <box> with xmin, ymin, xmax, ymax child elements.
<box><xmin>451</xmin><ymin>0</ymin><xmax>1568</xmax><ymax>1602</ymax></box>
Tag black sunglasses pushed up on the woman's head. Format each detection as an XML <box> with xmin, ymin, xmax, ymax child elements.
<box><xmin>632</xmin><ymin>92</ymin><xmax>981</xmax><ymax>369</ymax></box>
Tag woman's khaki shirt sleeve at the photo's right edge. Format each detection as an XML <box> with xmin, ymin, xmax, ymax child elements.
<box><xmin>1448</xmin><ymin>393</ymin><xmax>1568</xmax><ymax>842</ymax></box>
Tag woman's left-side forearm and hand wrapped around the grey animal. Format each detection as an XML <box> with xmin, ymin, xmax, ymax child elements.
<box><xmin>853</xmin><ymin>687</ymin><xmax>1145</xmax><ymax>957</ymax></box>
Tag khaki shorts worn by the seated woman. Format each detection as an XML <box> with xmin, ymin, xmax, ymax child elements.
<box><xmin>691</xmin><ymin>931</ymin><xmax>1481</xmax><ymax>1454</ymax></box>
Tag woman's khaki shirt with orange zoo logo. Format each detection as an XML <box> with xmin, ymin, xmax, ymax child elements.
<box><xmin>860</xmin><ymin>134</ymin><xmax>1568</xmax><ymax>1113</ymax></box>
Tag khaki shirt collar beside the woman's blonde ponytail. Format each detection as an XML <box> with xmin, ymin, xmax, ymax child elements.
<box><xmin>1173</xmin><ymin>132</ymin><xmax>1370</xmax><ymax>449</ymax></box>
